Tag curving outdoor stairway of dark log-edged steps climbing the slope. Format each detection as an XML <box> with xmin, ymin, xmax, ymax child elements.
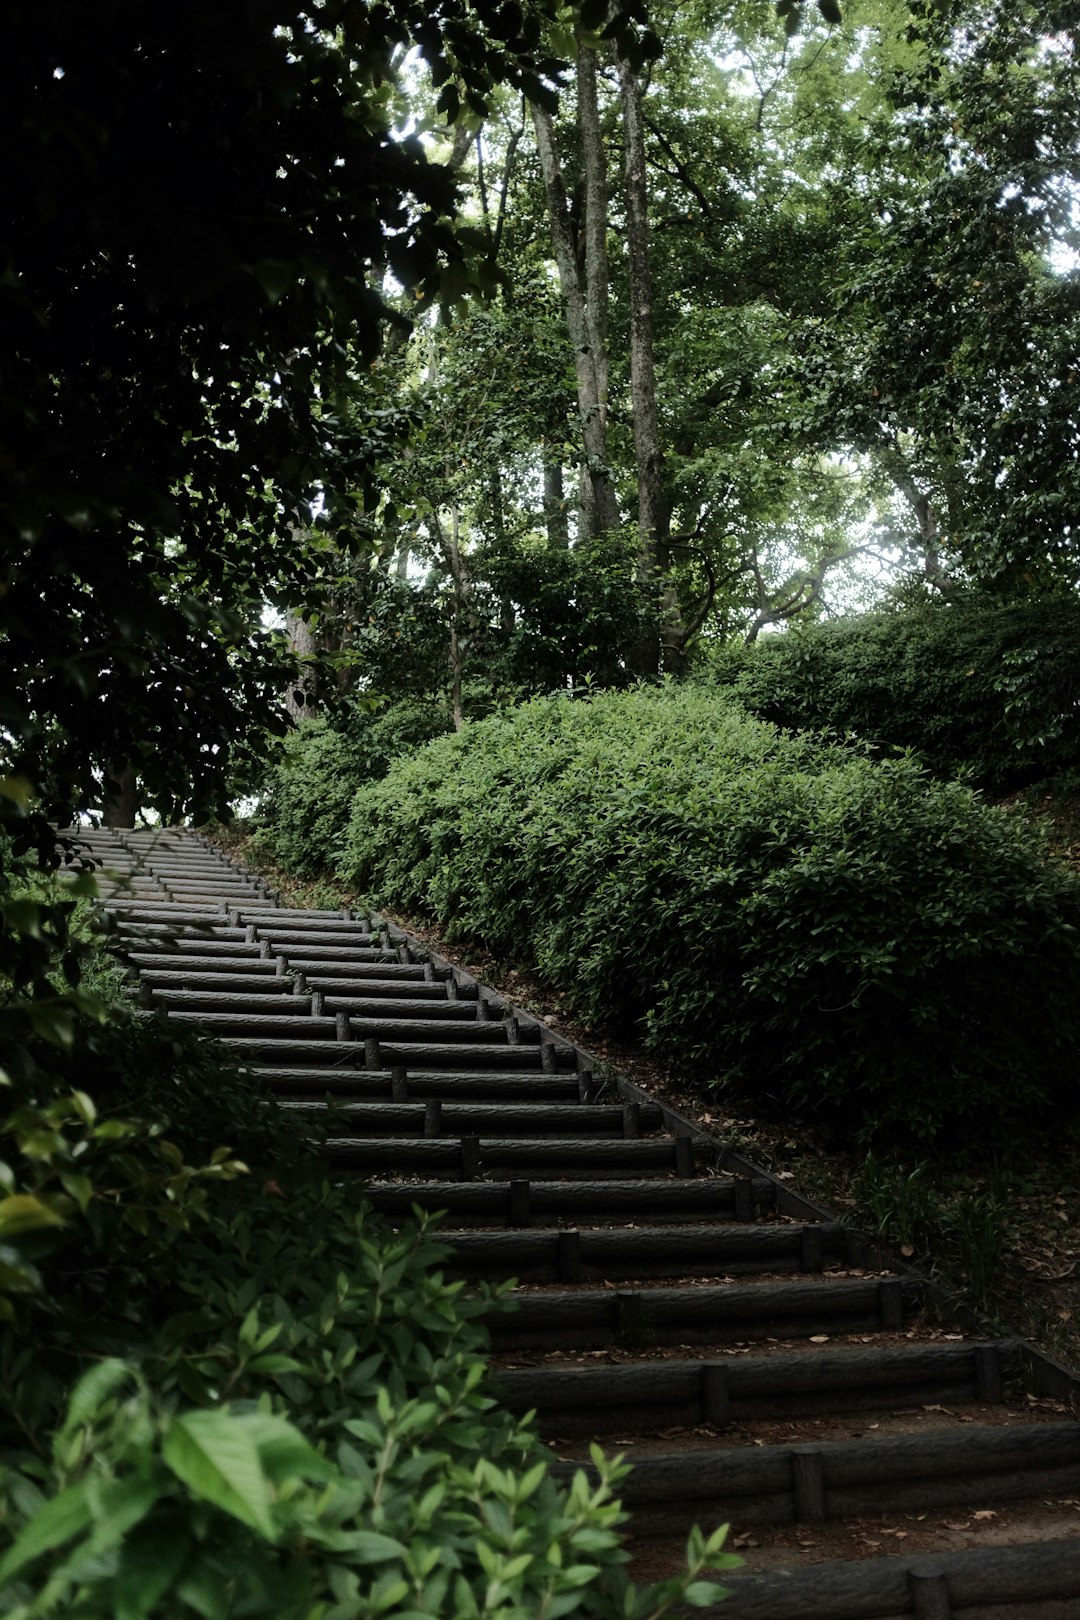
<box><xmin>78</xmin><ymin>829</ymin><xmax>1080</xmax><ymax>1620</ymax></box>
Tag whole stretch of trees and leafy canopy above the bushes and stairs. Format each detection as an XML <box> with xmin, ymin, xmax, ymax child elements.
<box><xmin>0</xmin><ymin>0</ymin><xmax>1080</xmax><ymax>835</ymax></box>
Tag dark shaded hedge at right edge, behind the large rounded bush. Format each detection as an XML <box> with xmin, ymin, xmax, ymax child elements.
<box><xmin>714</xmin><ymin>596</ymin><xmax>1080</xmax><ymax>791</ymax></box>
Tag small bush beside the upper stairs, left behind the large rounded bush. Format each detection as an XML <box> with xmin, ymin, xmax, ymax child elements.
<box><xmin>254</xmin><ymin>698</ymin><xmax>452</xmax><ymax>878</ymax></box>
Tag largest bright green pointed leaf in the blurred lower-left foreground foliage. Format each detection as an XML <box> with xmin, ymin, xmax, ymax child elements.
<box><xmin>162</xmin><ymin>1408</ymin><xmax>277</xmax><ymax>1541</ymax></box>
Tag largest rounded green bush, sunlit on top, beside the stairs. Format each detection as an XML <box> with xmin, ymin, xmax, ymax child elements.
<box><xmin>343</xmin><ymin>689</ymin><xmax>1080</xmax><ymax>1136</ymax></box>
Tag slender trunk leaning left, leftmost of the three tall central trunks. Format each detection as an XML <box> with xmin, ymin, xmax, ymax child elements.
<box><xmin>531</xmin><ymin>107</ymin><xmax>619</xmax><ymax>536</ymax></box>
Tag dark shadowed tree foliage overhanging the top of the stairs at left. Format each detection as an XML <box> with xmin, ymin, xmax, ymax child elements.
<box><xmin>0</xmin><ymin>0</ymin><xmax>573</xmax><ymax>842</ymax></box>
